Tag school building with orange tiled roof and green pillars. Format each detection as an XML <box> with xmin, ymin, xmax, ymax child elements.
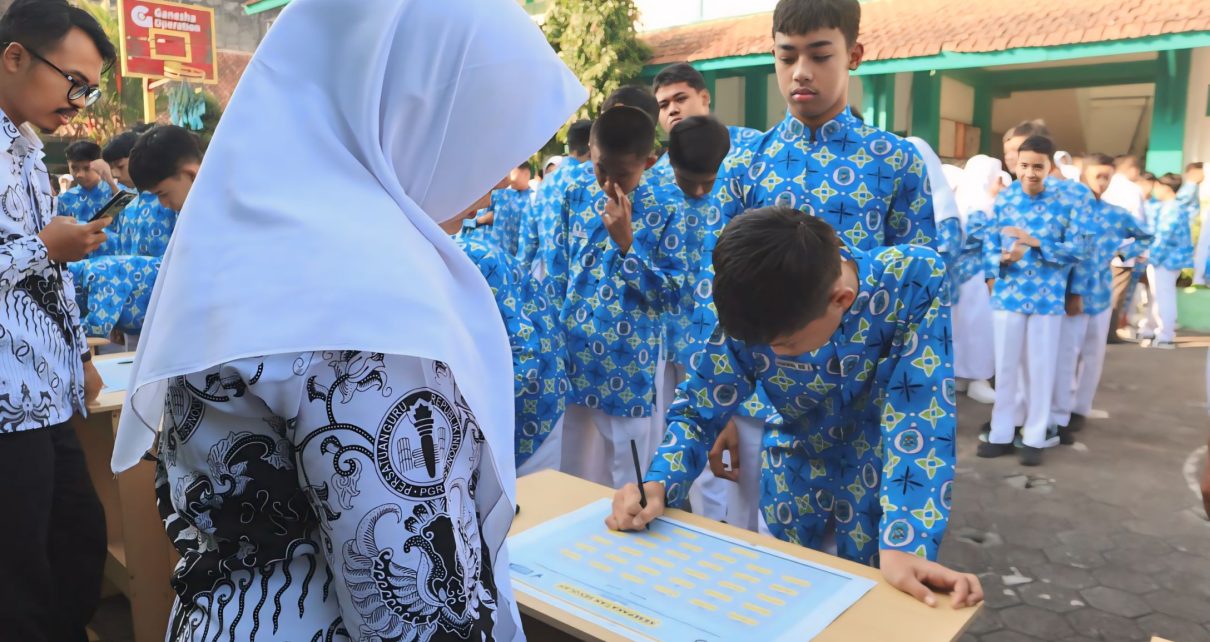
<box><xmin>640</xmin><ymin>0</ymin><xmax>1210</xmax><ymax>173</ymax></box>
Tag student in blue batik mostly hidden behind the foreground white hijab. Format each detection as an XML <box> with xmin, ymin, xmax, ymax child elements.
<box><xmin>440</xmin><ymin>196</ymin><xmax>567</xmax><ymax>475</ymax></box>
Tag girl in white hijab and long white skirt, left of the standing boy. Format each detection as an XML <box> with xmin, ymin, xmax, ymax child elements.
<box><xmin>953</xmin><ymin>155</ymin><xmax>1003</xmax><ymax>404</ymax></box>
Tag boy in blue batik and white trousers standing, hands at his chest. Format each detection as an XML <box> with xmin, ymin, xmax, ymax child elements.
<box><xmin>978</xmin><ymin>135</ymin><xmax>1085</xmax><ymax>465</ymax></box>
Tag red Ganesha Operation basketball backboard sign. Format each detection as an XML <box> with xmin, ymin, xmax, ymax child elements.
<box><xmin>117</xmin><ymin>0</ymin><xmax>218</xmax><ymax>82</ymax></box>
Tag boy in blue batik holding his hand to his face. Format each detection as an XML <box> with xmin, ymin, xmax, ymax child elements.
<box><xmin>547</xmin><ymin>106</ymin><xmax>684</xmax><ymax>487</ymax></box>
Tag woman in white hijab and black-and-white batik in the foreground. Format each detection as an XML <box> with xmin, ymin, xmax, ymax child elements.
<box><xmin>113</xmin><ymin>0</ymin><xmax>586</xmax><ymax>642</ymax></box>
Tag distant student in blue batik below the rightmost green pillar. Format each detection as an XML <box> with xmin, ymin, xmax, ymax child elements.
<box><xmin>1139</xmin><ymin>174</ymin><xmax>1199</xmax><ymax>349</ymax></box>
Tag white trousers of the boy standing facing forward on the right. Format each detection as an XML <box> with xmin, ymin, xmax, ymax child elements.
<box><xmin>989</xmin><ymin>310</ymin><xmax>1062</xmax><ymax>449</ymax></box>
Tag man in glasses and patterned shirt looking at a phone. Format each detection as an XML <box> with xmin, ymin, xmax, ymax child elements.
<box><xmin>0</xmin><ymin>0</ymin><xmax>115</xmax><ymax>642</ymax></box>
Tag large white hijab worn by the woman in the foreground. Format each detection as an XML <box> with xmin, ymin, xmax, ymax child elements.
<box><xmin>113</xmin><ymin>0</ymin><xmax>587</xmax><ymax>628</ymax></box>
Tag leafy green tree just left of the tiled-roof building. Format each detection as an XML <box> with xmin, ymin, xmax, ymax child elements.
<box><xmin>542</xmin><ymin>0</ymin><xmax>649</xmax><ymax>126</ymax></box>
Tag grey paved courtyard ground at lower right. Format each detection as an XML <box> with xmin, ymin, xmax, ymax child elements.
<box><xmin>96</xmin><ymin>337</ymin><xmax>1210</xmax><ymax>642</ymax></box>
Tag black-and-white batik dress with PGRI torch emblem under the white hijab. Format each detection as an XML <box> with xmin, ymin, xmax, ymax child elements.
<box><xmin>156</xmin><ymin>352</ymin><xmax>500</xmax><ymax>642</ymax></box>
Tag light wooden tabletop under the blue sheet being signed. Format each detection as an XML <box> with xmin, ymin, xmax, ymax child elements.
<box><xmin>509</xmin><ymin>470</ymin><xmax>983</xmax><ymax>642</ymax></box>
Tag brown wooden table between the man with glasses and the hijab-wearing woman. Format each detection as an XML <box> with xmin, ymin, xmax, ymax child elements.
<box><xmin>76</xmin><ymin>353</ymin><xmax>177</xmax><ymax>642</ymax></box>
